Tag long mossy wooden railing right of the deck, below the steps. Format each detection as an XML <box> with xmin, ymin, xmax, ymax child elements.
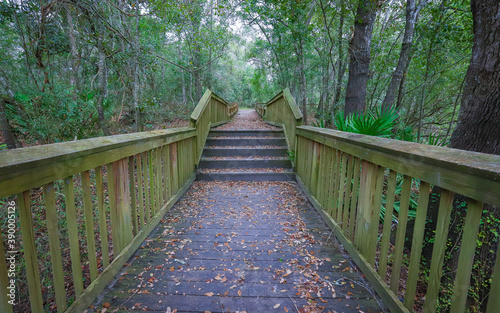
<box><xmin>296</xmin><ymin>126</ymin><xmax>500</xmax><ymax>313</ymax></box>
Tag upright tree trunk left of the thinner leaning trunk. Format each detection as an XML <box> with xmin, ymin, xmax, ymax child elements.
<box><xmin>344</xmin><ymin>0</ymin><xmax>380</xmax><ymax>115</ymax></box>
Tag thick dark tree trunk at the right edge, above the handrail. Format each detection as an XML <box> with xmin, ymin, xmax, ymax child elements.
<box><xmin>451</xmin><ymin>0</ymin><xmax>500</xmax><ymax>155</ymax></box>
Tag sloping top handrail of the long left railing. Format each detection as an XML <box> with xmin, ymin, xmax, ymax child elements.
<box><xmin>0</xmin><ymin>128</ymin><xmax>196</xmax><ymax>198</ymax></box>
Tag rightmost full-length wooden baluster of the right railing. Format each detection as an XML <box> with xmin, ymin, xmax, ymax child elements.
<box><xmin>450</xmin><ymin>200</ymin><xmax>482</xmax><ymax>313</ymax></box>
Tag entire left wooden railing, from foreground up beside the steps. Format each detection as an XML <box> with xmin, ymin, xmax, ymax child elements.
<box><xmin>0</xmin><ymin>92</ymin><xmax>228</xmax><ymax>313</ymax></box>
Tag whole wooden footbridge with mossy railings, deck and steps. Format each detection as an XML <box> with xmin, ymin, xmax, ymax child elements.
<box><xmin>0</xmin><ymin>90</ymin><xmax>500</xmax><ymax>313</ymax></box>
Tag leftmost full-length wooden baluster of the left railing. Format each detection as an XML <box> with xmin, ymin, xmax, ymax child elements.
<box><xmin>17</xmin><ymin>190</ymin><xmax>43</xmax><ymax>312</ymax></box>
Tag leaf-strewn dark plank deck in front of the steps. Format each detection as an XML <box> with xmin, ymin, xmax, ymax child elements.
<box><xmin>89</xmin><ymin>182</ymin><xmax>387</xmax><ymax>313</ymax></box>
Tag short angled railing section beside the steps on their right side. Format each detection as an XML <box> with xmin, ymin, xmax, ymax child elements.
<box><xmin>256</xmin><ymin>88</ymin><xmax>303</xmax><ymax>151</ymax></box>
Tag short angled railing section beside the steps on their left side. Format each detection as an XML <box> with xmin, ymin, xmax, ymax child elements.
<box><xmin>190</xmin><ymin>89</ymin><xmax>238</xmax><ymax>164</ymax></box>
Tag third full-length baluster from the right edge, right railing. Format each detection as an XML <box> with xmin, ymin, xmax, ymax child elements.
<box><xmin>405</xmin><ymin>181</ymin><xmax>431</xmax><ymax>311</ymax></box>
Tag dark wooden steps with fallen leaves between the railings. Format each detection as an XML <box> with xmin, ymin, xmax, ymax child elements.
<box><xmin>196</xmin><ymin>129</ymin><xmax>295</xmax><ymax>181</ymax></box>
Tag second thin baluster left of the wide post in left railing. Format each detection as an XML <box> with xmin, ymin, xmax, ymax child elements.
<box><xmin>82</xmin><ymin>171</ymin><xmax>97</xmax><ymax>281</ymax></box>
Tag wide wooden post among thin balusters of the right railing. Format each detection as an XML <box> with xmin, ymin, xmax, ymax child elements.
<box><xmin>354</xmin><ymin>160</ymin><xmax>384</xmax><ymax>266</ymax></box>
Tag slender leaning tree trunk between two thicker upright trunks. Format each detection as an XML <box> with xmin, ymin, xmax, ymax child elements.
<box><xmin>382</xmin><ymin>0</ymin><xmax>428</xmax><ymax>111</ymax></box>
